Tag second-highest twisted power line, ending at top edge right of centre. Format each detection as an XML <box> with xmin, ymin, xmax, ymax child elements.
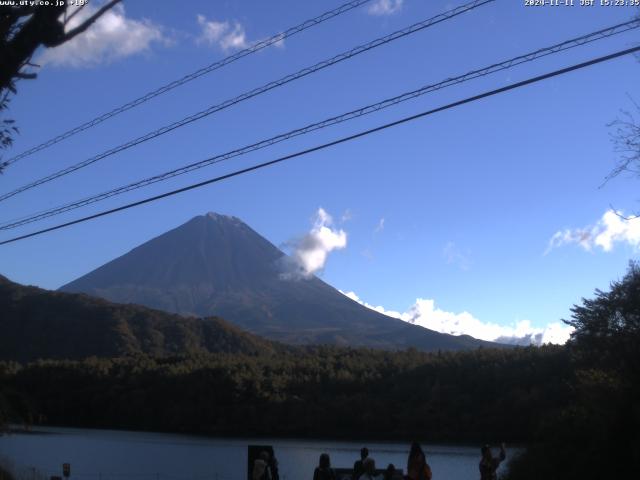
<box><xmin>0</xmin><ymin>0</ymin><xmax>496</xmax><ymax>201</ymax></box>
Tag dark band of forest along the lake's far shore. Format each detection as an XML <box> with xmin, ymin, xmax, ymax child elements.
<box><xmin>0</xmin><ymin>347</ymin><xmax>571</xmax><ymax>442</ymax></box>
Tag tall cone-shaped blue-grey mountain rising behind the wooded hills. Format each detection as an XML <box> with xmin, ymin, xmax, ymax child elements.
<box><xmin>60</xmin><ymin>213</ymin><xmax>496</xmax><ymax>351</ymax></box>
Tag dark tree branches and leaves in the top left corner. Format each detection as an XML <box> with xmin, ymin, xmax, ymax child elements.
<box><xmin>0</xmin><ymin>0</ymin><xmax>121</xmax><ymax>172</ymax></box>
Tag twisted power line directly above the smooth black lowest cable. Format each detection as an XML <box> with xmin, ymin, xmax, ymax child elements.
<box><xmin>0</xmin><ymin>19</ymin><xmax>640</xmax><ymax>230</ymax></box>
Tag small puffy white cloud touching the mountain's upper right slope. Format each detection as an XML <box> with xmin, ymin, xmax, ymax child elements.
<box><xmin>281</xmin><ymin>208</ymin><xmax>347</xmax><ymax>279</ymax></box>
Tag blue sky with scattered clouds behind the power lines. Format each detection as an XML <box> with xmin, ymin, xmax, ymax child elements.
<box><xmin>0</xmin><ymin>0</ymin><xmax>640</xmax><ymax>340</ymax></box>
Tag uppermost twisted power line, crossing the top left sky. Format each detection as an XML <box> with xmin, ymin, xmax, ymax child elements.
<box><xmin>5</xmin><ymin>0</ymin><xmax>371</xmax><ymax>165</ymax></box>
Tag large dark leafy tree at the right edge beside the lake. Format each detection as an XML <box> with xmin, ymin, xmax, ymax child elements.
<box><xmin>510</xmin><ymin>263</ymin><xmax>640</xmax><ymax>480</ymax></box>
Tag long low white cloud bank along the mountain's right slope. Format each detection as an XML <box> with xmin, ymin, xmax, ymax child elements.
<box><xmin>342</xmin><ymin>292</ymin><xmax>573</xmax><ymax>345</ymax></box>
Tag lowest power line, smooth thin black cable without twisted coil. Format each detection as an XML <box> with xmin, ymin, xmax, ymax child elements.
<box><xmin>0</xmin><ymin>46</ymin><xmax>640</xmax><ymax>245</ymax></box>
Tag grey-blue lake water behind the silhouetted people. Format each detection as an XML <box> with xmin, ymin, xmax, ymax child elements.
<box><xmin>0</xmin><ymin>428</ymin><xmax>504</xmax><ymax>480</ymax></box>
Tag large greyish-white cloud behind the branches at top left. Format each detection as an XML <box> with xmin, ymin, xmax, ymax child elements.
<box><xmin>36</xmin><ymin>4</ymin><xmax>169</xmax><ymax>67</ymax></box>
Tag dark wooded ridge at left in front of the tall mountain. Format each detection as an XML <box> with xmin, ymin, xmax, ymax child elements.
<box><xmin>0</xmin><ymin>276</ymin><xmax>281</xmax><ymax>362</ymax></box>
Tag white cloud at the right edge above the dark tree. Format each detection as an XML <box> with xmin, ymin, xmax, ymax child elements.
<box><xmin>545</xmin><ymin>210</ymin><xmax>640</xmax><ymax>255</ymax></box>
